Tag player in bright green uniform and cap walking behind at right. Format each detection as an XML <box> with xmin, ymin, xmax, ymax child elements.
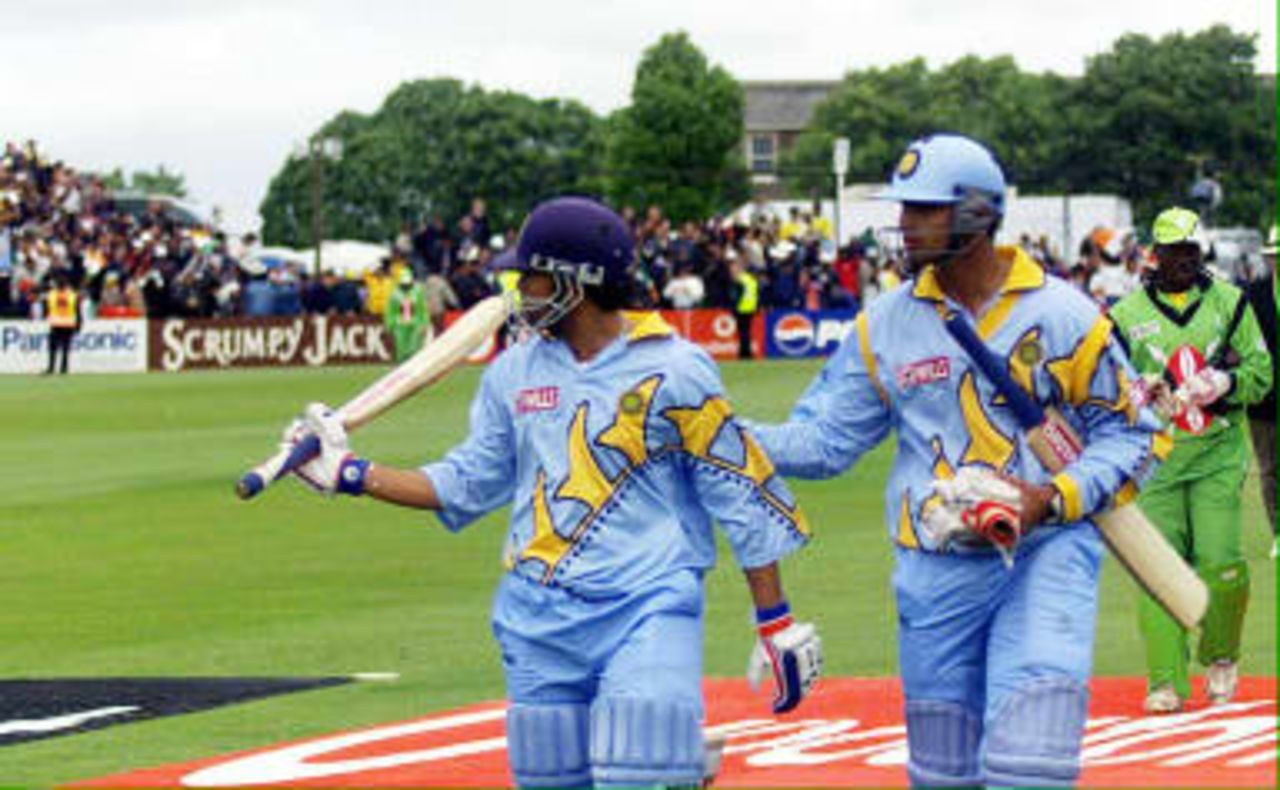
<box><xmin>1111</xmin><ymin>209</ymin><xmax>1271</xmax><ymax>713</ymax></box>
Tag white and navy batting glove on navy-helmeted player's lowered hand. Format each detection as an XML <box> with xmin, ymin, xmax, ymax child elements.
<box><xmin>746</xmin><ymin>602</ymin><xmax>822</xmax><ymax>713</ymax></box>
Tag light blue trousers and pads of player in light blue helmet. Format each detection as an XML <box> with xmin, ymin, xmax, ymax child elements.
<box><xmin>893</xmin><ymin>524</ymin><xmax>1103</xmax><ymax>784</ymax></box>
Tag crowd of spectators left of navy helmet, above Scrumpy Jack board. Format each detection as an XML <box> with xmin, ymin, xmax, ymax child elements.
<box><xmin>0</xmin><ymin>141</ymin><xmax>503</xmax><ymax>318</ymax></box>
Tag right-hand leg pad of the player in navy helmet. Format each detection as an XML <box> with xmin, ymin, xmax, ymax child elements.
<box><xmin>591</xmin><ymin>697</ymin><xmax>704</xmax><ymax>787</ymax></box>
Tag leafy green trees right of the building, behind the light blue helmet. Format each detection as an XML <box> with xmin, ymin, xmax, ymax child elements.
<box><xmin>782</xmin><ymin>26</ymin><xmax>1276</xmax><ymax>228</ymax></box>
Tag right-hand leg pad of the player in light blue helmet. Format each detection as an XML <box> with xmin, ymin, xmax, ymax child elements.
<box><xmin>983</xmin><ymin>677</ymin><xmax>1089</xmax><ymax>787</ymax></box>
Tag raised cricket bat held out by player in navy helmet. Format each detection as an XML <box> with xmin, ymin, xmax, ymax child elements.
<box><xmin>236</xmin><ymin>296</ymin><xmax>511</xmax><ymax>499</ymax></box>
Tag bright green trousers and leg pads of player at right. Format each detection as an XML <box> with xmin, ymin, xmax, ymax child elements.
<box><xmin>1138</xmin><ymin>434</ymin><xmax>1249</xmax><ymax>699</ymax></box>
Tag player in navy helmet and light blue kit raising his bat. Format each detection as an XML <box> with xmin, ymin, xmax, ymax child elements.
<box><xmin>279</xmin><ymin>197</ymin><xmax>822</xmax><ymax>787</ymax></box>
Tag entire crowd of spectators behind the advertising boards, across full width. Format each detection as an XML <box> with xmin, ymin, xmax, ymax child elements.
<box><xmin>0</xmin><ymin>142</ymin><xmax>1254</xmax><ymax>326</ymax></box>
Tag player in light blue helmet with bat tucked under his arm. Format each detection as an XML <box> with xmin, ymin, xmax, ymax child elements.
<box><xmin>755</xmin><ymin>134</ymin><xmax>1158</xmax><ymax>787</ymax></box>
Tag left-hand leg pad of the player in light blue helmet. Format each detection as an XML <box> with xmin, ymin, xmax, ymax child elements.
<box><xmin>906</xmin><ymin>699</ymin><xmax>982</xmax><ymax>787</ymax></box>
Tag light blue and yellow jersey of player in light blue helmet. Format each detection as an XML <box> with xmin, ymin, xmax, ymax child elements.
<box><xmin>753</xmin><ymin>247</ymin><xmax>1167</xmax><ymax>552</ymax></box>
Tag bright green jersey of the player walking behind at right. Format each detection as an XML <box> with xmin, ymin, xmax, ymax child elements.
<box><xmin>1110</xmin><ymin>278</ymin><xmax>1271</xmax><ymax>452</ymax></box>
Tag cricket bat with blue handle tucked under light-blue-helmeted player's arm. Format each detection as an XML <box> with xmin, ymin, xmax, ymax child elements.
<box><xmin>943</xmin><ymin>312</ymin><xmax>1208</xmax><ymax>629</ymax></box>
